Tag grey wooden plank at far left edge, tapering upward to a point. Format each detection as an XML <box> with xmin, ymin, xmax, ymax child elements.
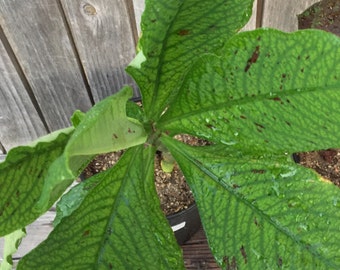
<box><xmin>0</xmin><ymin>37</ymin><xmax>46</xmax><ymax>150</ymax></box>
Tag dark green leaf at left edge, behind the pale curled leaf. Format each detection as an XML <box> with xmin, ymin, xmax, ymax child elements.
<box><xmin>0</xmin><ymin>128</ymin><xmax>74</xmax><ymax>236</ymax></box>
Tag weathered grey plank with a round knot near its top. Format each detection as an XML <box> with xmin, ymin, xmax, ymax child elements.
<box><xmin>61</xmin><ymin>0</ymin><xmax>137</xmax><ymax>102</ymax></box>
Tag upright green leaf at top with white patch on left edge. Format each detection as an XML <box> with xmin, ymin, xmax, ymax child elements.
<box><xmin>127</xmin><ymin>0</ymin><xmax>253</xmax><ymax>121</ymax></box>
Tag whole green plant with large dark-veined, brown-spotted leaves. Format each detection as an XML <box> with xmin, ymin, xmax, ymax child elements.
<box><xmin>0</xmin><ymin>0</ymin><xmax>340</xmax><ymax>269</ymax></box>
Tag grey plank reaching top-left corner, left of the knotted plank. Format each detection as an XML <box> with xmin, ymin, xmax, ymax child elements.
<box><xmin>0</xmin><ymin>0</ymin><xmax>91</xmax><ymax>130</ymax></box>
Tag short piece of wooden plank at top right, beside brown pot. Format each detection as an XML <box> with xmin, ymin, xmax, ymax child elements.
<box><xmin>262</xmin><ymin>0</ymin><xmax>320</xmax><ymax>32</ymax></box>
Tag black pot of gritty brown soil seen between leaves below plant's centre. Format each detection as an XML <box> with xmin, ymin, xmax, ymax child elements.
<box><xmin>82</xmin><ymin>148</ymin><xmax>202</xmax><ymax>245</ymax></box>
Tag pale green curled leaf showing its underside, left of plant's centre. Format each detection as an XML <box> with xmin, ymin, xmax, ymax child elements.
<box><xmin>35</xmin><ymin>87</ymin><xmax>146</xmax><ymax>212</ymax></box>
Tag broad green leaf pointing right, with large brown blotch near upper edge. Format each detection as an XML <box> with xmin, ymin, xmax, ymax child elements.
<box><xmin>158</xmin><ymin>29</ymin><xmax>340</xmax><ymax>153</ymax></box>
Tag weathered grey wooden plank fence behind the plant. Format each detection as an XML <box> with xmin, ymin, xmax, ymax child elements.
<box><xmin>0</xmin><ymin>0</ymin><xmax>317</xmax><ymax>154</ymax></box>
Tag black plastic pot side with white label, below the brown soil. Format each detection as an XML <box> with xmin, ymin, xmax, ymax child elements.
<box><xmin>167</xmin><ymin>203</ymin><xmax>201</xmax><ymax>245</ymax></box>
